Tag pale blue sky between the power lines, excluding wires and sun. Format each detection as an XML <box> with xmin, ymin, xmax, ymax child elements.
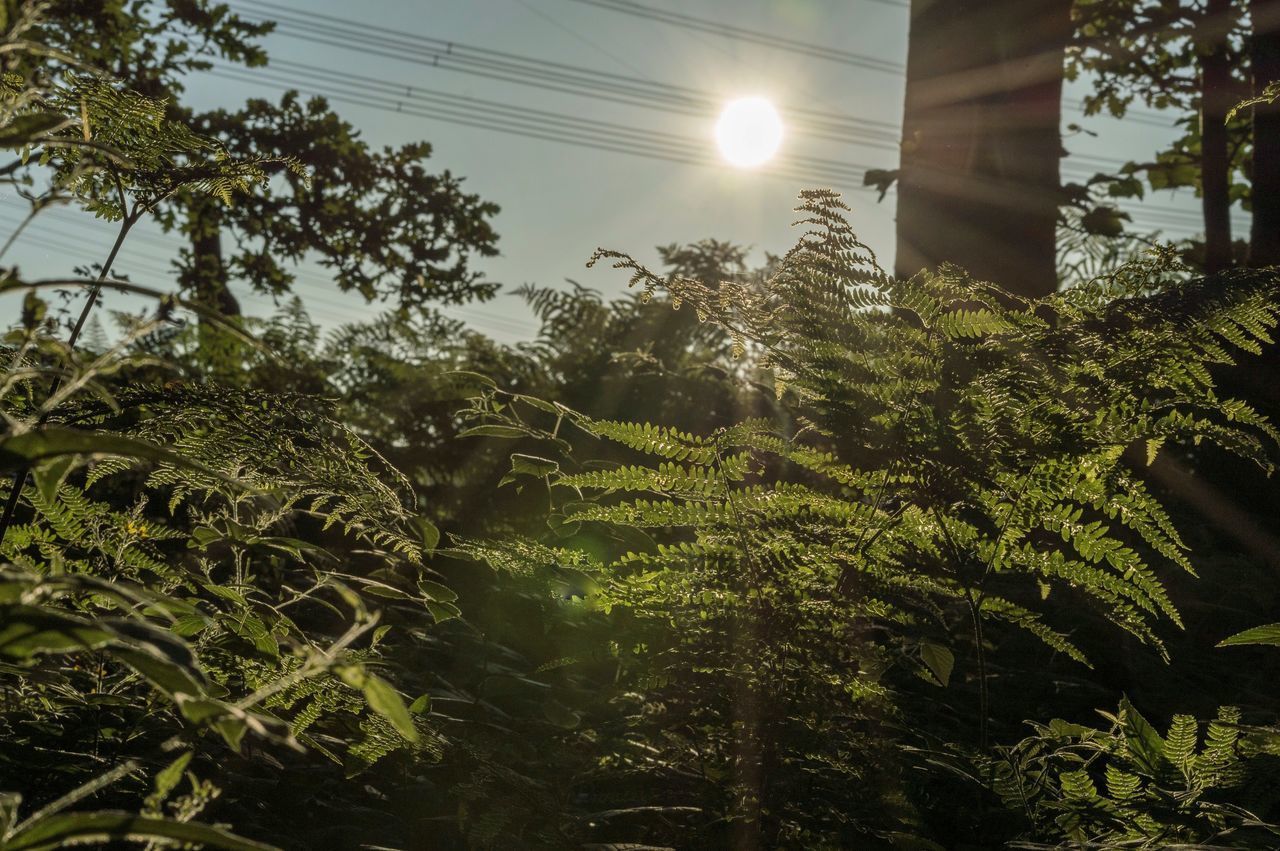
<box><xmin>0</xmin><ymin>0</ymin><xmax>1233</xmax><ymax>339</ymax></box>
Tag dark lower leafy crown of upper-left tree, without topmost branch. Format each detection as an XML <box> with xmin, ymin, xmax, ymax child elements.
<box><xmin>175</xmin><ymin>92</ymin><xmax>498</xmax><ymax>314</ymax></box>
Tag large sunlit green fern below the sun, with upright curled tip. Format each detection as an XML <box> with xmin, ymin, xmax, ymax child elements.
<box><xmin>465</xmin><ymin>192</ymin><xmax>1277</xmax><ymax>845</ymax></box>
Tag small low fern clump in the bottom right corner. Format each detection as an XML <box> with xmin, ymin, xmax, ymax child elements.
<box><xmin>983</xmin><ymin>700</ymin><xmax>1280</xmax><ymax>848</ymax></box>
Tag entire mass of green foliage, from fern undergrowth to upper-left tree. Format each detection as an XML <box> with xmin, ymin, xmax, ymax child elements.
<box><xmin>0</xmin><ymin>0</ymin><xmax>1280</xmax><ymax>851</ymax></box>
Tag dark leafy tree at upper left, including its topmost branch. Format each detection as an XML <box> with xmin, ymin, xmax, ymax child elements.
<box><xmin>30</xmin><ymin>0</ymin><xmax>498</xmax><ymax>322</ymax></box>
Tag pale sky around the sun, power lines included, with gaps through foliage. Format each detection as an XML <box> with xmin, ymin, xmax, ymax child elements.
<box><xmin>0</xmin><ymin>0</ymin><xmax>1247</xmax><ymax>342</ymax></box>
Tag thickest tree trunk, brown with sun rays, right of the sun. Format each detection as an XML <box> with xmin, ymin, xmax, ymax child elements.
<box><xmin>895</xmin><ymin>0</ymin><xmax>1071</xmax><ymax>297</ymax></box>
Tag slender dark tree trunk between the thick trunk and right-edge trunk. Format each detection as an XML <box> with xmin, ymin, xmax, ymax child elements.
<box><xmin>1196</xmin><ymin>0</ymin><xmax>1231</xmax><ymax>274</ymax></box>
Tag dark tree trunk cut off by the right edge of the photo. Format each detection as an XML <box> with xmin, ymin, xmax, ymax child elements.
<box><xmin>1249</xmin><ymin>0</ymin><xmax>1280</xmax><ymax>266</ymax></box>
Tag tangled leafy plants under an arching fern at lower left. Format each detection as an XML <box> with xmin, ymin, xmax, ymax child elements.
<box><xmin>0</xmin><ymin>319</ymin><xmax>447</xmax><ymax>844</ymax></box>
